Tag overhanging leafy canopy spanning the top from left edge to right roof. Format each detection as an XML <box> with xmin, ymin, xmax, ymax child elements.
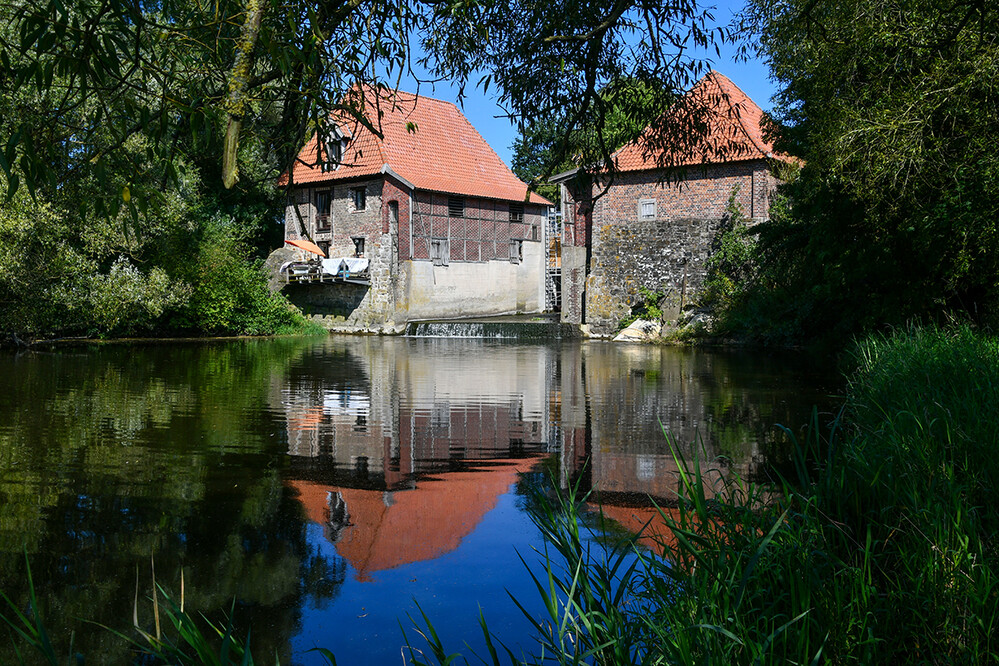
<box><xmin>0</xmin><ymin>0</ymin><xmax>728</xmax><ymax>205</ymax></box>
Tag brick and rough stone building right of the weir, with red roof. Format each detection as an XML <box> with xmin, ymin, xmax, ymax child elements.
<box><xmin>552</xmin><ymin>72</ymin><xmax>790</xmax><ymax>334</ymax></box>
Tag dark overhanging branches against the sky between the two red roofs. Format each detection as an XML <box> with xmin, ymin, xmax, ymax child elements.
<box><xmin>424</xmin><ymin>0</ymin><xmax>726</xmax><ymax>192</ymax></box>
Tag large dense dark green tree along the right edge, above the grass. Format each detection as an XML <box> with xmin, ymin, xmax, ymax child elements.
<box><xmin>743</xmin><ymin>0</ymin><xmax>999</xmax><ymax>336</ymax></box>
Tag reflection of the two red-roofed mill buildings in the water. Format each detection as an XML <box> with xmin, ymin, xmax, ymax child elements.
<box><xmin>280</xmin><ymin>338</ymin><xmax>816</xmax><ymax>580</ymax></box>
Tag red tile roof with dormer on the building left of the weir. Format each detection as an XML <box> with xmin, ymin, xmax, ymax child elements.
<box><xmin>279</xmin><ymin>88</ymin><xmax>550</xmax><ymax>204</ymax></box>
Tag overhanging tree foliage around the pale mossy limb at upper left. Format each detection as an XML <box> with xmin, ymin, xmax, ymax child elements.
<box><xmin>0</xmin><ymin>0</ymin><xmax>416</xmax><ymax>213</ymax></box>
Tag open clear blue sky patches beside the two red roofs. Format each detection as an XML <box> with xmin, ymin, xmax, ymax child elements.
<box><xmin>394</xmin><ymin>0</ymin><xmax>776</xmax><ymax>165</ymax></box>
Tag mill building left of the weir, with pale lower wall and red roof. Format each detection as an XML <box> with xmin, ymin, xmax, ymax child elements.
<box><xmin>281</xmin><ymin>88</ymin><xmax>550</xmax><ymax>328</ymax></box>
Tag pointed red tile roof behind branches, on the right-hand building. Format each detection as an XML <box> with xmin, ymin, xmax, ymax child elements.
<box><xmin>613</xmin><ymin>72</ymin><xmax>794</xmax><ymax>171</ymax></box>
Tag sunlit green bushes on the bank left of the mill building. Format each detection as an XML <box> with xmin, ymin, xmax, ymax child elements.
<box><xmin>0</xmin><ymin>173</ymin><xmax>308</xmax><ymax>342</ymax></box>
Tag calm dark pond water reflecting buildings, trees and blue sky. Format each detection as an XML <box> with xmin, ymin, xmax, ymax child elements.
<box><xmin>0</xmin><ymin>337</ymin><xmax>838</xmax><ymax>665</ymax></box>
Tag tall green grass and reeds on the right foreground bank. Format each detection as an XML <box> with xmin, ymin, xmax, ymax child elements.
<box><xmin>404</xmin><ymin>328</ymin><xmax>999</xmax><ymax>664</ymax></box>
